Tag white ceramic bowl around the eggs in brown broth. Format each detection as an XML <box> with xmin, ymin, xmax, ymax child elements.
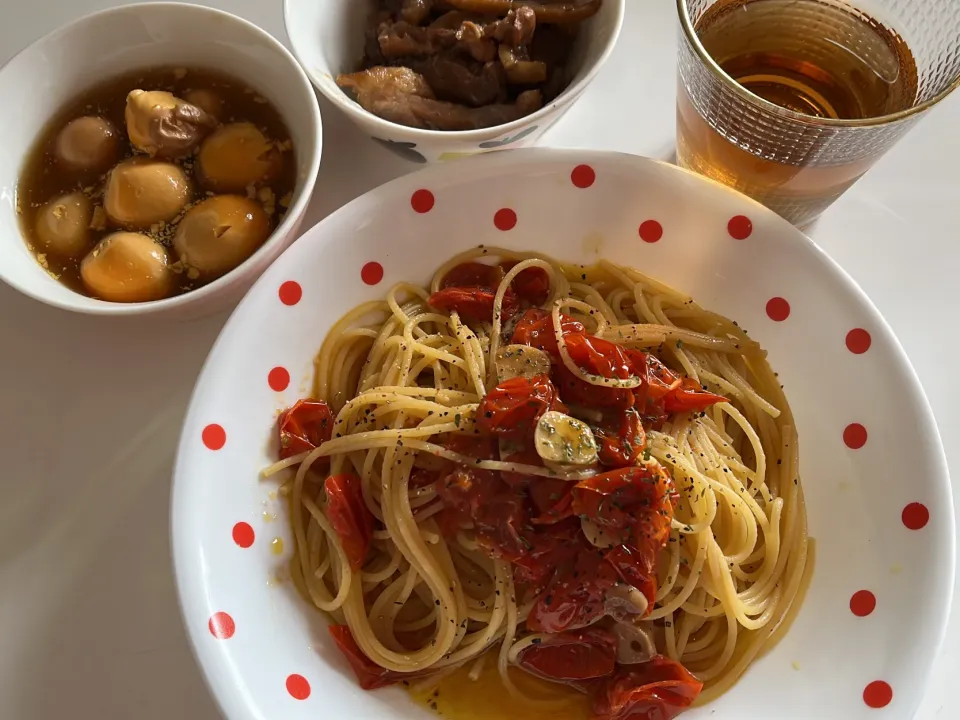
<box><xmin>0</xmin><ymin>3</ymin><xmax>322</xmax><ymax>316</ymax></box>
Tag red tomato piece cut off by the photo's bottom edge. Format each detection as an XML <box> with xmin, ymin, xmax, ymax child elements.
<box><xmin>591</xmin><ymin>655</ymin><xmax>703</xmax><ymax>720</ymax></box>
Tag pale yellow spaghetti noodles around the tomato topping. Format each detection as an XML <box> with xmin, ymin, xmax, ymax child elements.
<box><xmin>265</xmin><ymin>248</ymin><xmax>812</xmax><ymax>716</ymax></box>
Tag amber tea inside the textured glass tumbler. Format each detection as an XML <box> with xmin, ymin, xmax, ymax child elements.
<box><xmin>677</xmin><ymin>0</ymin><xmax>918</xmax><ymax>225</ymax></box>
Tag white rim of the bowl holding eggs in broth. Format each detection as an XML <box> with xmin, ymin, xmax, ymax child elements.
<box><xmin>0</xmin><ymin>1</ymin><xmax>323</xmax><ymax>316</ymax></box>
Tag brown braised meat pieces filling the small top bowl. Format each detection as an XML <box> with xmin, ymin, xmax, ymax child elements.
<box><xmin>337</xmin><ymin>0</ymin><xmax>603</xmax><ymax>130</ymax></box>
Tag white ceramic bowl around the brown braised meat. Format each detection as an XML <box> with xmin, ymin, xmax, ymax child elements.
<box><xmin>283</xmin><ymin>0</ymin><xmax>626</xmax><ymax>163</ymax></box>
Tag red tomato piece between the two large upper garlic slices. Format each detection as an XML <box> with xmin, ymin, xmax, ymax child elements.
<box><xmin>477</xmin><ymin>375</ymin><xmax>558</xmax><ymax>438</ymax></box>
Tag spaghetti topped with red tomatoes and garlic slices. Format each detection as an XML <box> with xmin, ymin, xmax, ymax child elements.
<box><xmin>265</xmin><ymin>248</ymin><xmax>812</xmax><ymax>718</ymax></box>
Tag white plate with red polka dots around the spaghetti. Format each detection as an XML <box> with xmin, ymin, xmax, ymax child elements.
<box><xmin>172</xmin><ymin>150</ymin><xmax>955</xmax><ymax>720</ymax></box>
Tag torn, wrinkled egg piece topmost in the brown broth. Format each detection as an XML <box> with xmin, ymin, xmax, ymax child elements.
<box><xmin>124</xmin><ymin>90</ymin><xmax>217</xmax><ymax>158</ymax></box>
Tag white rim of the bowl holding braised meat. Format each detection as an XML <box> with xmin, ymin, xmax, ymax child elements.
<box><xmin>283</xmin><ymin>0</ymin><xmax>627</xmax><ymax>142</ymax></box>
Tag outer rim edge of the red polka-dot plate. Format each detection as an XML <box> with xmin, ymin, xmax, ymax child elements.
<box><xmin>170</xmin><ymin>148</ymin><xmax>957</xmax><ymax>720</ymax></box>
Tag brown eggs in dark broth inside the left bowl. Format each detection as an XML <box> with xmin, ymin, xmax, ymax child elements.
<box><xmin>17</xmin><ymin>67</ymin><xmax>296</xmax><ymax>302</ymax></box>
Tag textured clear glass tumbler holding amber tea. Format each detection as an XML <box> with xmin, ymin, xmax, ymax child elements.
<box><xmin>677</xmin><ymin>0</ymin><xmax>960</xmax><ymax>227</ymax></box>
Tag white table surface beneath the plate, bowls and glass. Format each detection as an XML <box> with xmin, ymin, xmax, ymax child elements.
<box><xmin>0</xmin><ymin>0</ymin><xmax>960</xmax><ymax>720</ymax></box>
